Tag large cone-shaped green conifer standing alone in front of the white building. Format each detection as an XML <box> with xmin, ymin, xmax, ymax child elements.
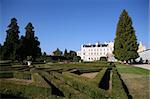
<box><xmin>113</xmin><ymin>10</ymin><xmax>138</xmax><ymax>61</ymax></box>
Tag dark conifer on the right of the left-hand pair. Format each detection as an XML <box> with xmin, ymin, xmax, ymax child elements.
<box><xmin>18</xmin><ymin>23</ymin><xmax>41</xmax><ymax>61</ymax></box>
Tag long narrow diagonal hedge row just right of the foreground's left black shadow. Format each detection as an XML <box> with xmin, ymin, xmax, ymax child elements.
<box><xmin>40</xmin><ymin>71</ymin><xmax>91</xmax><ymax>99</ymax></box>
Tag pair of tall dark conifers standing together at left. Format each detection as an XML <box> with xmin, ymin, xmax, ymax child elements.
<box><xmin>0</xmin><ymin>18</ymin><xmax>41</xmax><ymax>61</ymax></box>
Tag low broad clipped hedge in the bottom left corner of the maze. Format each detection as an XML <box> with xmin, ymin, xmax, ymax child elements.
<box><xmin>0</xmin><ymin>81</ymin><xmax>51</xmax><ymax>98</ymax></box>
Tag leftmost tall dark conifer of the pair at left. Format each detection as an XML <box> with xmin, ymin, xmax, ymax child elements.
<box><xmin>1</xmin><ymin>18</ymin><xmax>20</xmax><ymax>60</ymax></box>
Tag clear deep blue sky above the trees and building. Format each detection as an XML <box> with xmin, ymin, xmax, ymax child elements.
<box><xmin>0</xmin><ymin>0</ymin><xmax>150</xmax><ymax>54</ymax></box>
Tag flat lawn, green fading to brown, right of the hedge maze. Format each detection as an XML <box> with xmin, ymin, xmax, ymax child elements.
<box><xmin>116</xmin><ymin>64</ymin><xmax>150</xmax><ymax>99</ymax></box>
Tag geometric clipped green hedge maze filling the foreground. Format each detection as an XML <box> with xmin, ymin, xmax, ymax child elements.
<box><xmin>0</xmin><ymin>62</ymin><xmax>129</xmax><ymax>99</ymax></box>
